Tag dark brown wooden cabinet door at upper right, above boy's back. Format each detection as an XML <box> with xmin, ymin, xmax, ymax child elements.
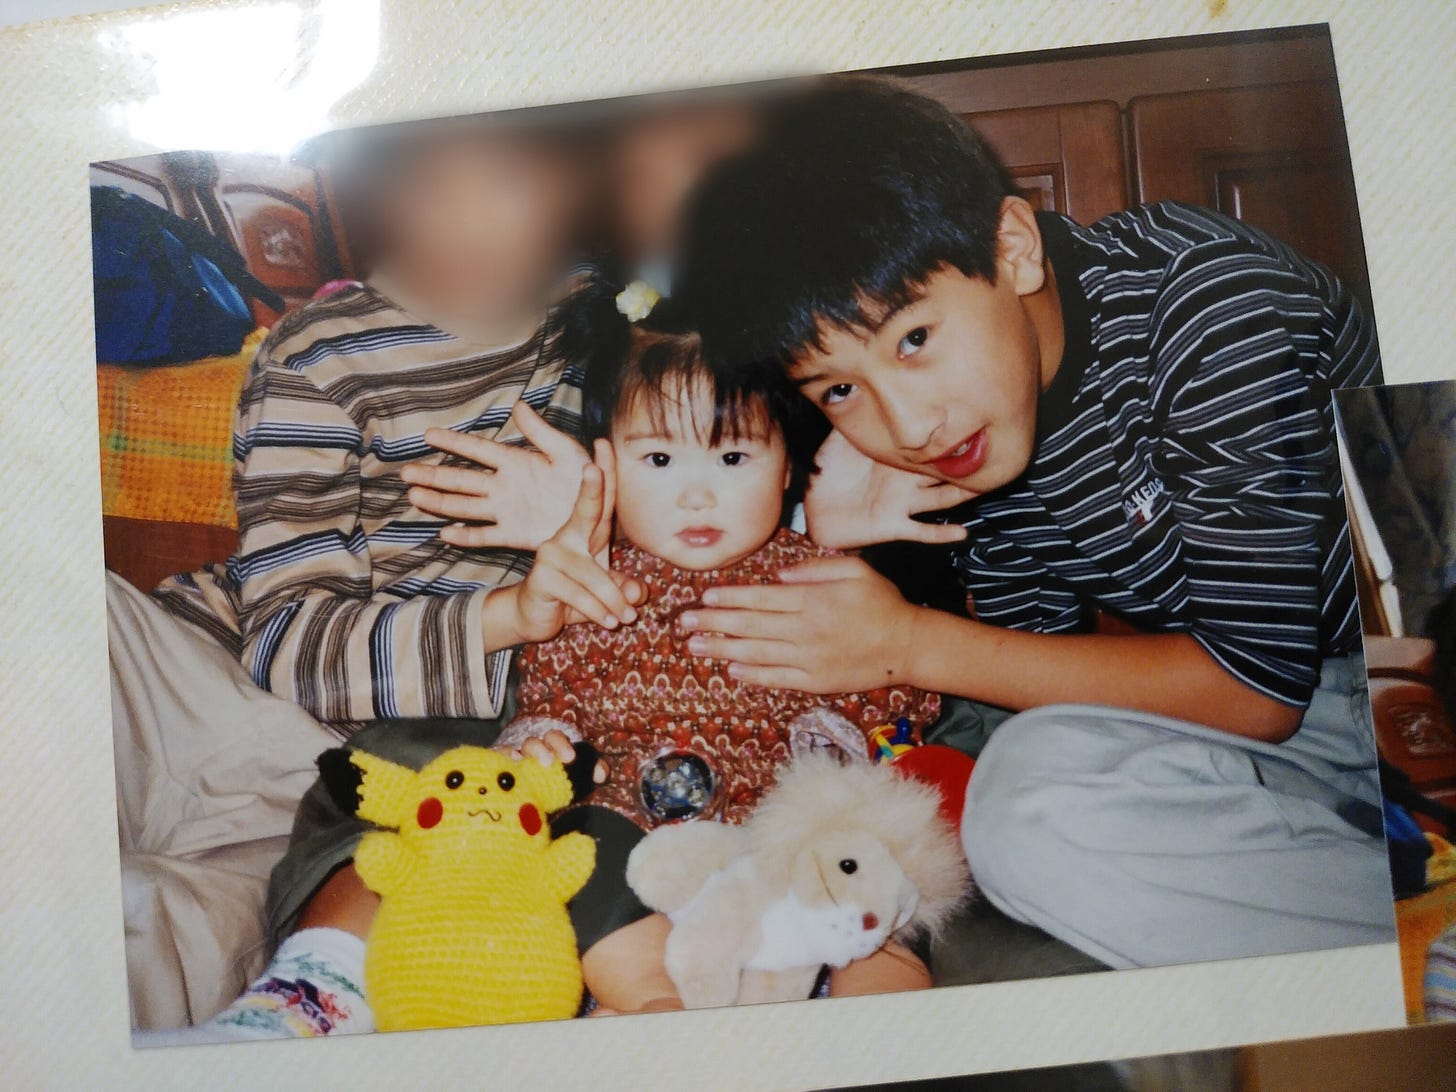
<box><xmin>1127</xmin><ymin>80</ymin><xmax>1370</xmax><ymax>300</ymax></box>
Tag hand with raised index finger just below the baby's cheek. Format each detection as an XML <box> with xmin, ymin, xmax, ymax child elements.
<box><xmin>514</xmin><ymin>440</ymin><xmax>644</xmax><ymax>642</ymax></box>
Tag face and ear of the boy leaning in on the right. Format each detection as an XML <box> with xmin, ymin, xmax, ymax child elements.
<box><xmin>789</xmin><ymin>199</ymin><xmax>1061</xmax><ymax>494</ymax></box>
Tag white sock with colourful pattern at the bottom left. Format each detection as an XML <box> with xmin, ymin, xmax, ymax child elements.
<box><xmin>132</xmin><ymin>929</ymin><xmax>374</xmax><ymax>1047</ymax></box>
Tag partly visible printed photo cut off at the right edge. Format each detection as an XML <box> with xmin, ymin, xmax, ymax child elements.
<box><xmin>1335</xmin><ymin>381</ymin><xmax>1456</xmax><ymax>1024</ymax></box>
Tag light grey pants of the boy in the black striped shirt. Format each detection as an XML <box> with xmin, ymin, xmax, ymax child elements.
<box><xmin>961</xmin><ymin>657</ymin><xmax>1395</xmax><ymax>967</ymax></box>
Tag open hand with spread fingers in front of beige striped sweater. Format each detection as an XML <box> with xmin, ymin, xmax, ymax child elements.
<box><xmin>399</xmin><ymin>402</ymin><xmax>590</xmax><ymax>550</ymax></box>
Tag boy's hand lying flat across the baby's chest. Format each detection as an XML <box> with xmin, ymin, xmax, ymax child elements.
<box><xmin>680</xmin><ymin>558</ymin><xmax>920</xmax><ymax>695</ymax></box>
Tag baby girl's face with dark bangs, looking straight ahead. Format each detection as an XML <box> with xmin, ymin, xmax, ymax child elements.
<box><xmin>612</xmin><ymin>383</ymin><xmax>789</xmax><ymax>571</ymax></box>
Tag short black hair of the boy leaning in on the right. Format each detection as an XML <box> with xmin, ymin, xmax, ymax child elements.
<box><xmin>678</xmin><ymin>77</ymin><xmax>1015</xmax><ymax>374</ymax></box>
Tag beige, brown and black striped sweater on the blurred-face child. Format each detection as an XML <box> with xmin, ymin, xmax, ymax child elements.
<box><xmin>157</xmin><ymin>285</ymin><xmax>581</xmax><ymax>731</ymax></box>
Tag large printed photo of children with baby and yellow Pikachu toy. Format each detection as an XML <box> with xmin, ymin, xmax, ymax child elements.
<box><xmin>90</xmin><ymin>26</ymin><xmax>1397</xmax><ymax>1047</ymax></box>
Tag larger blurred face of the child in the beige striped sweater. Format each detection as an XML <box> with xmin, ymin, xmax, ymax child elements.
<box><xmin>376</xmin><ymin>131</ymin><xmax>578</xmax><ymax>319</ymax></box>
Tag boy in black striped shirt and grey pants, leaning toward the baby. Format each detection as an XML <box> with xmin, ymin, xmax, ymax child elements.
<box><xmin>678</xmin><ymin>79</ymin><xmax>1393</xmax><ymax>967</ymax></box>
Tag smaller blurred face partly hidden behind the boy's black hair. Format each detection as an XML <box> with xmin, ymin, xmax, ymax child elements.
<box><xmin>610</xmin><ymin>102</ymin><xmax>754</xmax><ymax>264</ymax></box>
